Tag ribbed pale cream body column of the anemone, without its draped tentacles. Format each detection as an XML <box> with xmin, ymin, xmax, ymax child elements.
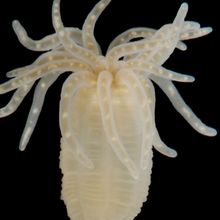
<box><xmin>60</xmin><ymin>82</ymin><xmax>152</xmax><ymax>220</ymax></box>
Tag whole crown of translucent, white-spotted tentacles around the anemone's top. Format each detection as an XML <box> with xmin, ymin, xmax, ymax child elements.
<box><xmin>0</xmin><ymin>0</ymin><xmax>216</xmax><ymax>178</ymax></box>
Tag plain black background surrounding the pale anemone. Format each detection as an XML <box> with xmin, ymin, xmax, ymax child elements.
<box><xmin>0</xmin><ymin>0</ymin><xmax>220</xmax><ymax>220</ymax></box>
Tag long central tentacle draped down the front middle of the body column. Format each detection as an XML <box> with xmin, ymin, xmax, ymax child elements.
<box><xmin>97</xmin><ymin>71</ymin><xmax>138</xmax><ymax>179</ymax></box>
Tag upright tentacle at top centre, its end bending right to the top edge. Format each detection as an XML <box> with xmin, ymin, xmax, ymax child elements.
<box><xmin>82</xmin><ymin>0</ymin><xmax>111</xmax><ymax>54</ymax></box>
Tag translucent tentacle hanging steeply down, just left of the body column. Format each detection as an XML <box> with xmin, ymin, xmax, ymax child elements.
<box><xmin>19</xmin><ymin>72</ymin><xmax>61</xmax><ymax>151</ymax></box>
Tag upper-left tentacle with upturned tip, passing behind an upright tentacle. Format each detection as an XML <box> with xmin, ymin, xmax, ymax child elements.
<box><xmin>12</xmin><ymin>20</ymin><xmax>82</xmax><ymax>51</ymax></box>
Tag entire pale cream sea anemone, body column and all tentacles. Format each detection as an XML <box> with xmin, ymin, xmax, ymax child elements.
<box><xmin>0</xmin><ymin>0</ymin><xmax>217</xmax><ymax>220</ymax></box>
